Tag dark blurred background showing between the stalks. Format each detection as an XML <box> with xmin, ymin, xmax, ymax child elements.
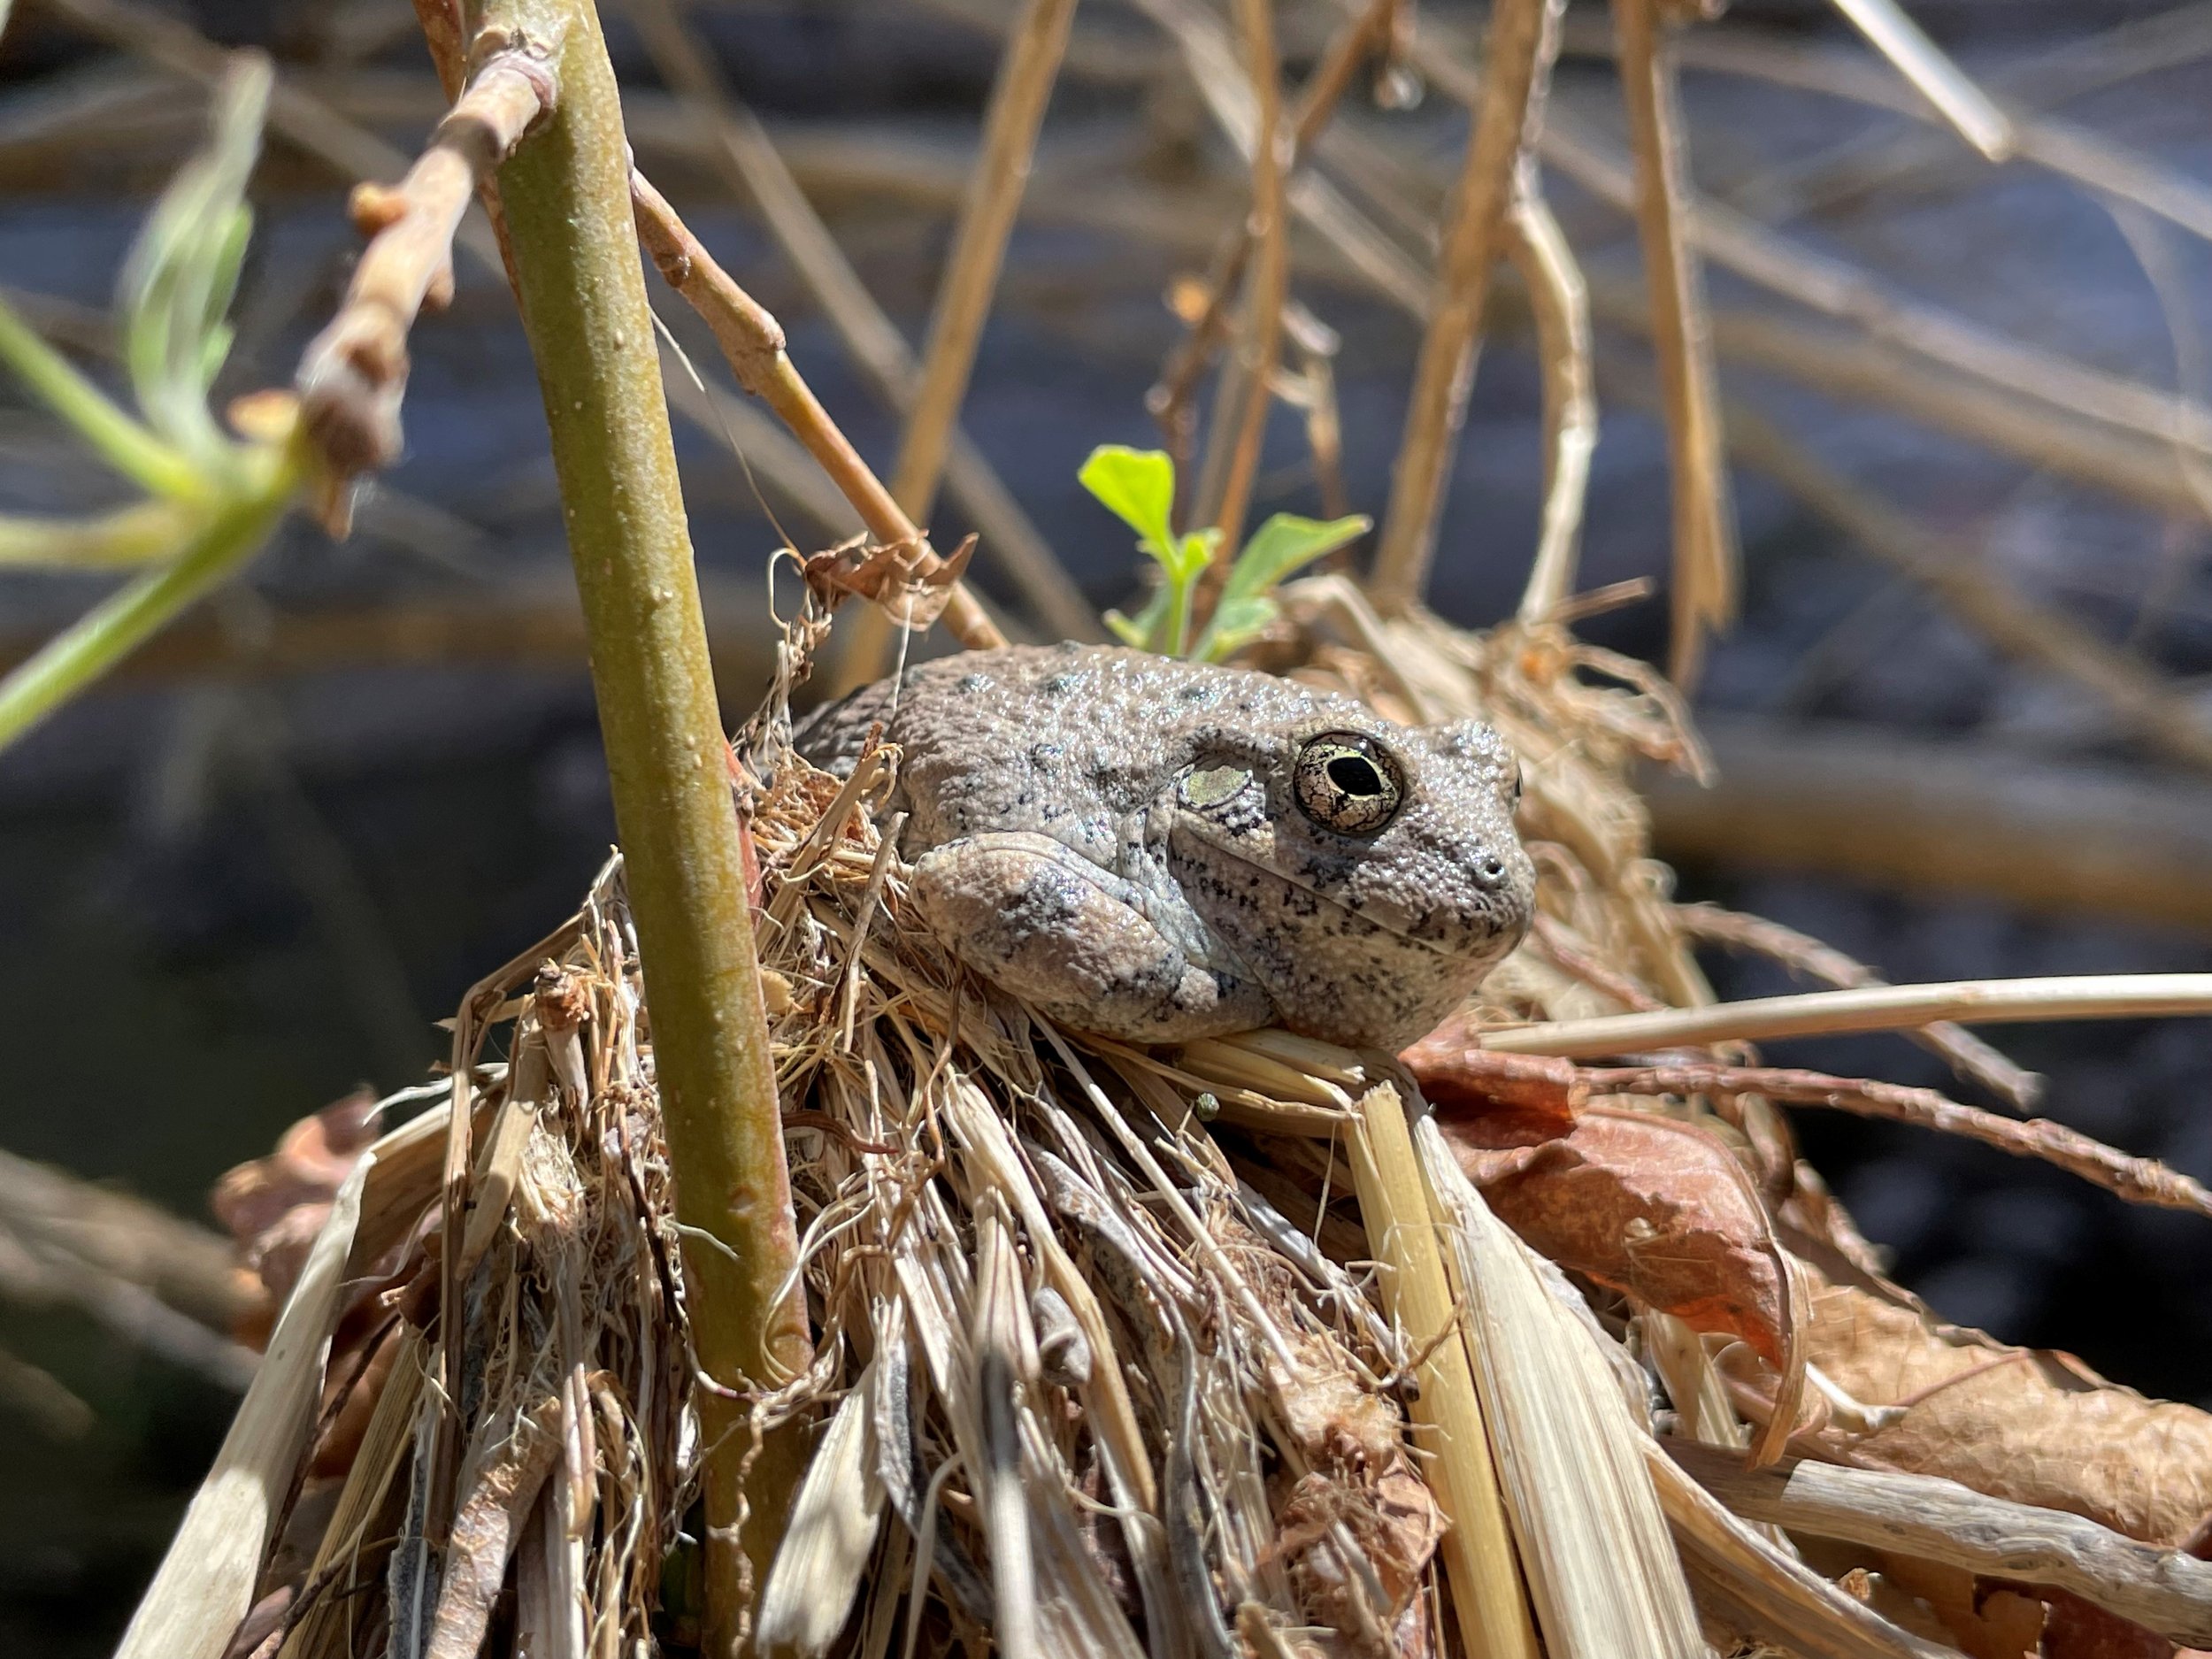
<box><xmin>0</xmin><ymin>0</ymin><xmax>2212</xmax><ymax>1655</ymax></box>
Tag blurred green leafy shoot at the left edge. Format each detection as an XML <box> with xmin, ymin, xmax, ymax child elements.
<box><xmin>0</xmin><ymin>53</ymin><xmax>308</xmax><ymax>748</ymax></box>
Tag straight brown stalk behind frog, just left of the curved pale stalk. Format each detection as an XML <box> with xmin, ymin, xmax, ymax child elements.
<box><xmin>1370</xmin><ymin>0</ymin><xmax>1564</xmax><ymax>615</ymax></box>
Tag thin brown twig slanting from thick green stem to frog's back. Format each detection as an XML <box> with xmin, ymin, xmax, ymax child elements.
<box><xmin>631</xmin><ymin>171</ymin><xmax>1007</xmax><ymax>650</ymax></box>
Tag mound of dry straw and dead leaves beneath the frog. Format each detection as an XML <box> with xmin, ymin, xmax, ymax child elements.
<box><xmin>157</xmin><ymin>578</ymin><xmax>2212</xmax><ymax>1659</ymax></box>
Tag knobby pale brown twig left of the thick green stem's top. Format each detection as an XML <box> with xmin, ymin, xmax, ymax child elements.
<box><xmin>299</xmin><ymin>40</ymin><xmax>560</xmax><ymax>480</ymax></box>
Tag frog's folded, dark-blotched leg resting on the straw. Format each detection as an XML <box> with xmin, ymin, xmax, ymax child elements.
<box><xmin>910</xmin><ymin>830</ymin><xmax>1274</xmax><ymax>1042</ymax></box>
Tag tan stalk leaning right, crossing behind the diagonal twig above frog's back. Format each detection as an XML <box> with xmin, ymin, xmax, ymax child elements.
<box><xmin>832</xmin><ymin>0</ymin><xmax>1075</xmax><ymax>693</ymax></box>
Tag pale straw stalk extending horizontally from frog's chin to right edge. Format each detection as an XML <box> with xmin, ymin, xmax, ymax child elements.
<box><xmin>1480</xmin><ymin>973</ymin><xmax>2212</xmax><ymax>1060</ymax></box>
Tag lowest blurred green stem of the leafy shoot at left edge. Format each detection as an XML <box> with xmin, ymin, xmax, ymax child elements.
<box><xmin>0</xmin><ymin>451</ymin><xmax>301</xmax><ymax>748</ymax></box>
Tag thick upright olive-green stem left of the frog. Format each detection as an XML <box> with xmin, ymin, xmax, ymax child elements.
<box><xmin>485</xmin><ymin>0</ymin><xmax>810</xmax><ymax>1655</ymax></box>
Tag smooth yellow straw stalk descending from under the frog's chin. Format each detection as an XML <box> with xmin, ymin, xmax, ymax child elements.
<box><xmin>1345</xmin><ymin>1084</ymin><xmax>1538</xmax><ymax>1659</ymax></box>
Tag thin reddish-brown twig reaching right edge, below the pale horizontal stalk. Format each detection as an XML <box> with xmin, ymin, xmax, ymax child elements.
<box><xmin>1578</xmin><ymin>1064</ymin><xmax>2212</xmax><ymax>1217</ymax></box>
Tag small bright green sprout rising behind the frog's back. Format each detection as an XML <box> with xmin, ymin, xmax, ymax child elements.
<box><xmin>1078</xmin><ymin>445</ymin><xmax>1371</xmax><ymax>662</ymax></box>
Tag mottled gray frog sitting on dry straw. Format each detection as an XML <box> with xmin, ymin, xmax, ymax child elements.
<box><xmin>799</xmin><ymin>646</ymin><xmax>1535</xmax><ymax>1048</ymax></box>
